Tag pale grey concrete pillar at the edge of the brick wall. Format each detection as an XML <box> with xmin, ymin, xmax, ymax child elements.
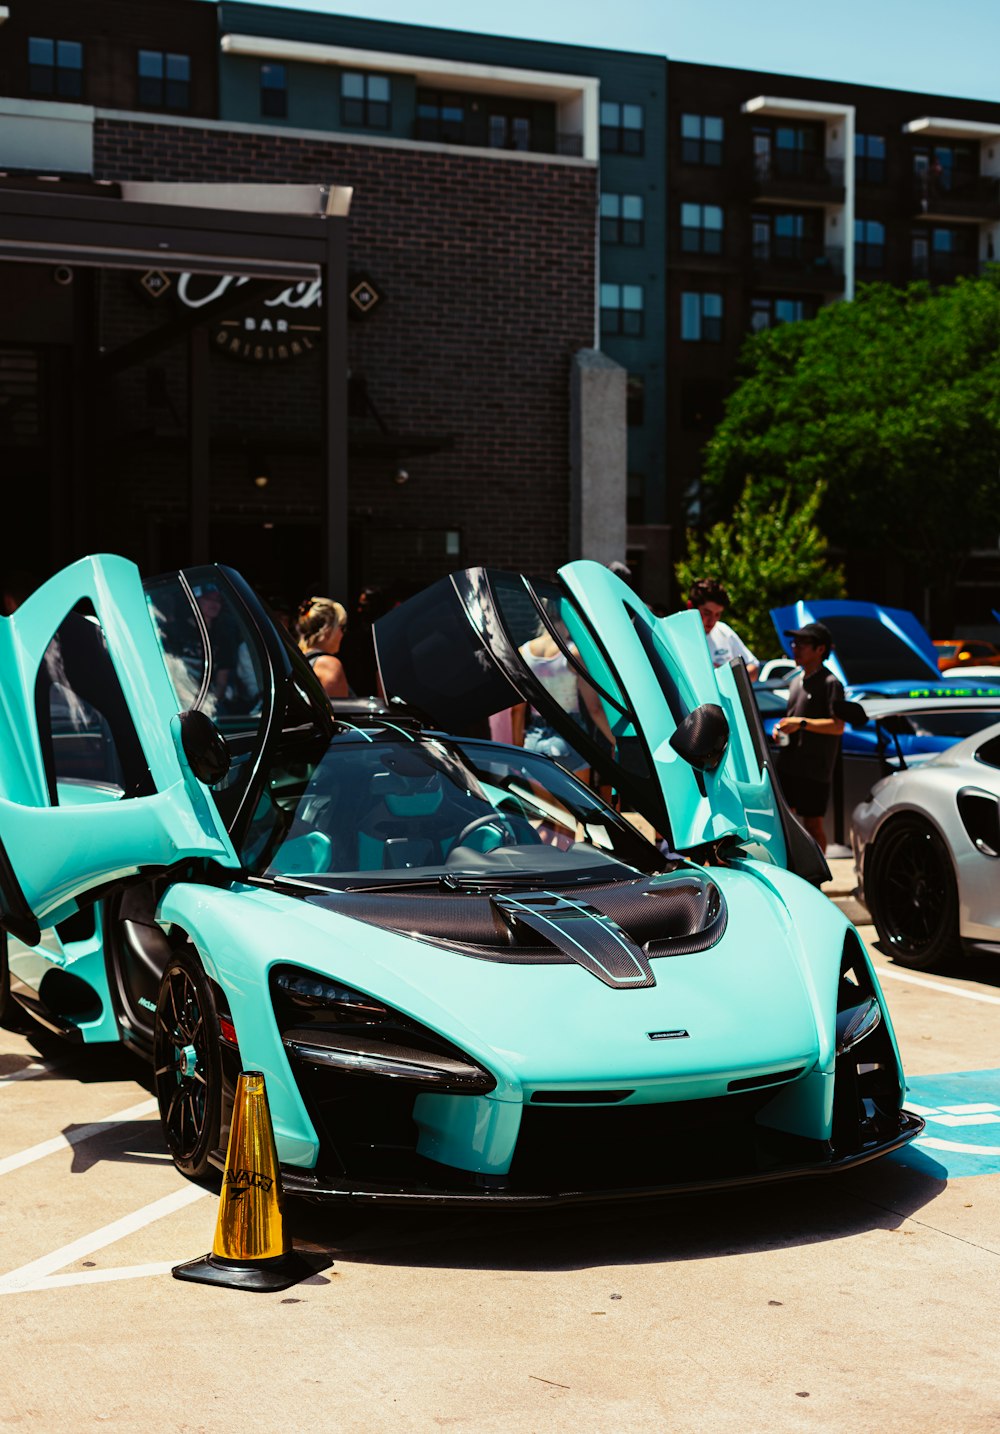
<box><xmin>570</xmin><ymin>348</ymin><xmax>628</xmax><ymax>562</ymax></box>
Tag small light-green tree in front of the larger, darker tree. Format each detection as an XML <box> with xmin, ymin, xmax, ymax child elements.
<box><xmin>676</xmin><ymin>483</ymin><xmax>845</xmax><ymax>661</ymax></box>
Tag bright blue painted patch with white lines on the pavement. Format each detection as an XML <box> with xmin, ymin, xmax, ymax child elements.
<box><xmin>891</xmin><ymin>1070</ymin><xmax>1000</xmax><ymax>1180</ymax></box>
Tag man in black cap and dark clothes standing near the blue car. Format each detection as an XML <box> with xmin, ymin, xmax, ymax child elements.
<box><xmin>775</xmin><ymin>622</ymin><xmax>844</xmax><ymax>852</ymax></box>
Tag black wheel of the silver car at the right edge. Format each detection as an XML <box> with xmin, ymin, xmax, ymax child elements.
<box><xmin>865</xmin><ymin>816</ymin><xmax>961</xmax><ymax>971</ymax></box>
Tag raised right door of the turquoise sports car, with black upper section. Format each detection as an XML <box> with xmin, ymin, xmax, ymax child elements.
<box><xmin>376</xmin><ymin>562</ymin><xmax>826</xmax><ymax>880</ymax></box>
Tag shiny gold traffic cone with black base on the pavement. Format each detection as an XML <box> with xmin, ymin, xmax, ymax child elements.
<box><xmin>174</xmin><ymin>1071</ymin><xmax>330</xmax><ymax>1291</ymax></box>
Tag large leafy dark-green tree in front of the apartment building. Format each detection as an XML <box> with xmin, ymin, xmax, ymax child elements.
<box><xmin>704</xmin><ymin>267</ymin><xmax>1000</xmax><ymax>596</ymax></box>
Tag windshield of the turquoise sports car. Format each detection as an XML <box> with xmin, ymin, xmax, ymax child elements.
<box><xmin>242</xmin><ymin>728</ymin><xmax>666</xmax><ymax>886</ymax></box>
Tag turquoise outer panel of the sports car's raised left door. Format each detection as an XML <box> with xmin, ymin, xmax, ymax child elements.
<box><xmin>0</xmin><ymin>556</ymin><xmax>238</xmax><ymax>945</ymax></box>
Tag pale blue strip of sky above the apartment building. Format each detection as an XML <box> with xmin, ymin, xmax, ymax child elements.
<box><xmin>223</xmin><ymin>0</ymin><xmax>1000</xmax><ymax>100</ymax></box>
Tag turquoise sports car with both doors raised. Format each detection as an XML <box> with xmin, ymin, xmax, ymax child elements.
<box><xmin>0</xmin><ymin>556</ymin><xmax>921</xmax><ymax>1206</ymax></box>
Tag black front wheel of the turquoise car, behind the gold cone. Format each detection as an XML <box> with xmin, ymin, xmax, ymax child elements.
<box><xmin>154</xmin><ymin>946</ymin><xmax>222</xmax><ymax>1180</ymax></box>
